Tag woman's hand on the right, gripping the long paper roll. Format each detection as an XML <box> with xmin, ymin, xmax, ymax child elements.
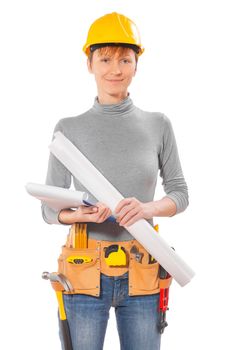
<box><xmin>115</xmin><ymin>197</ymin><xmax>155</xmax><ymax>226</ymax></box>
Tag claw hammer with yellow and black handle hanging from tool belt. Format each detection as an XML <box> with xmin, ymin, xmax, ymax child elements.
<box><xmin>42</xmin><ymin>271</ymin><xmax>73</xmax><ymax>350</ymax></box>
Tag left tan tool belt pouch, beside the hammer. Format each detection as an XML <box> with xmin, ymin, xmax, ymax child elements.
<box><xmin>58</xmin><ymin>247</ymin><xmax>100</xmax><ymax>295</ymax></box>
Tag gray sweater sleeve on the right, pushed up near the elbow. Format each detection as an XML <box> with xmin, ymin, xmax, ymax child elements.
<box><xmin>159</xmin><ymin>115</ymin><xmax>189</xmax><ymax>214</ymax></box>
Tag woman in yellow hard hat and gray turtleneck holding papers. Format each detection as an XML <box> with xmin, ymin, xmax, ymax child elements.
<box><xmin>42</xmin><ymin>13</ymin><xmax>188</xmax><ymax>350</ymax></box>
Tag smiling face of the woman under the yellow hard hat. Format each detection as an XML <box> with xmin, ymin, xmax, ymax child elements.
<box><xmin>87</xmin><ymin>49</ymin><xmax>137</xmax><ymax>97</ymax></box>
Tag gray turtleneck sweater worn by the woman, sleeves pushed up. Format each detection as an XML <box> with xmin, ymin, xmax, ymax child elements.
<box><xmin>42</xmin><ymin>96</ymin><xmax>188</xmax><ymax>241</ymax></box>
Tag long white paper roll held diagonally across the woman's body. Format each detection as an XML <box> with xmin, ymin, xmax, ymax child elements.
<box><xmin>49</xmin><ymin>131</ymin><xmax>194</xmax><ymax>286</ymax></box>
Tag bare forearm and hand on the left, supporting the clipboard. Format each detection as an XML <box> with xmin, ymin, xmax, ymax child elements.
<box><xmin>58</xmin><ymin>202</ymin><xmax>112</xmax><ymax>224</ymax></box>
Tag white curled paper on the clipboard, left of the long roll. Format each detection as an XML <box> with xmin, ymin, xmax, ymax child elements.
<box><xmin>25</xmin><ymin>182</ymin><xmax>94</xmax><ymax>210</ymax></box>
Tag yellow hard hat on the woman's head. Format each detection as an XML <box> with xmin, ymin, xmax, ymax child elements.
<box><xmin>83</xmin><ymin>12</ymin><xmax>144</xmax><ymax>56</ymax></box>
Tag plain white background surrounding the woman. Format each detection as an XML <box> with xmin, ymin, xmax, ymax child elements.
<box><xmin>0</xmin><ymin>0</ymin><xmax>233</xmax><ymax>350</ymax></box>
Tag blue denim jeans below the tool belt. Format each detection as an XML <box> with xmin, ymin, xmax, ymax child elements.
<box><xmin>60</xmin><ymin>272</ymin><xmax>161</xmax><ymax>350</ymax></box>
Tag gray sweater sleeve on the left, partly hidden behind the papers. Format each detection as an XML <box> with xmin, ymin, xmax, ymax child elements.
<box><xmin>41</xmin><ymin>121</ymin><xmax>71</xmax><ymax>224</ymax></box>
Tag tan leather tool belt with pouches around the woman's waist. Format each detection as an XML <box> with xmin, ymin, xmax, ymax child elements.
<box><xmin>52</xmin><ymin>224</ymin><xmax>172</xmax><ymax>296</ymax></box>
